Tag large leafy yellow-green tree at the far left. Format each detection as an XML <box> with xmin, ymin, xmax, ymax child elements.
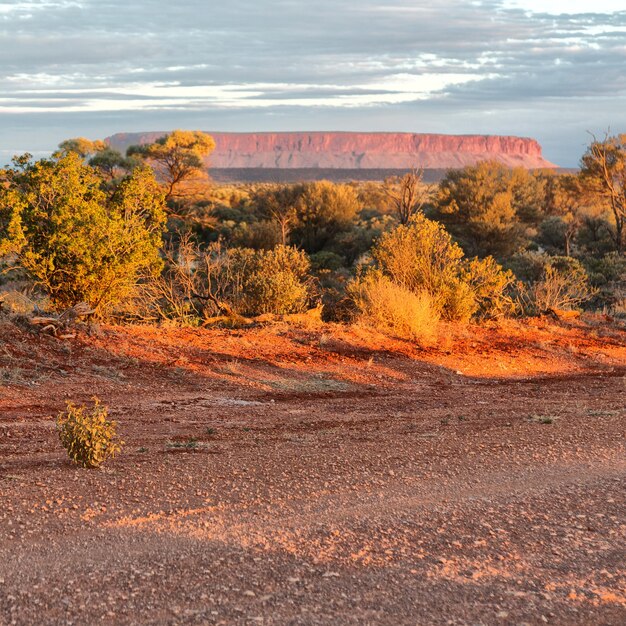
<box><xmin>0</xmin><ymin>152</ymin><xmax>165</xmax><ymax>312</ymax></box>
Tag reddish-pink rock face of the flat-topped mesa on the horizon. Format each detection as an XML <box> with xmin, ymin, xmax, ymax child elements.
<box><xmin>107</xmin><ymin>131</ymin><xmax>555</xmax><ymax>169</ymax></box>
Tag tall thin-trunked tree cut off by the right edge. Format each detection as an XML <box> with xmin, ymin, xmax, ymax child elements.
<box><xmin>580</xmin><ymin>134</ymin><xmax>626</xmax><ymax>254</ymax></box>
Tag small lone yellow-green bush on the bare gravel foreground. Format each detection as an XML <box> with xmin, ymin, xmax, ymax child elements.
<box><xmin>57</xmin><ymin>398</ymin><xmax>123</xmax><ymax>467</ymax></box>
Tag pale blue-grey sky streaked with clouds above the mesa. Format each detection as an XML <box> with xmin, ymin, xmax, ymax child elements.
<box><xmin>0</xmin><ymin>0</ymin><xmax>626</xmax><ymax>167</ymax></box>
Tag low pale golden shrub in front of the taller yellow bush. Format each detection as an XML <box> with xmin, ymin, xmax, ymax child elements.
<box><xmin>347</xmin><ymin>270</ymin><xmax>439</xmax><ymax>343</ymax></box>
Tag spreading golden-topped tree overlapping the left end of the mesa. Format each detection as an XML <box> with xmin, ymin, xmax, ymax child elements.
<box><xmin>126</xmin><ymin>130</ymin><xmax>215</xmax><ymax>200</ymax></box>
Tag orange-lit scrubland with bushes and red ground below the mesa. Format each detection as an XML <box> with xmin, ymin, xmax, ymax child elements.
<box><xmin>0</xmin><ymin>131</ymin><xmax>626</xmax><ymax>625</ymax></box>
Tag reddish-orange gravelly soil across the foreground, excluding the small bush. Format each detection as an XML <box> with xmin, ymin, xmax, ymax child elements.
<box><xmin>0</xmin><ymin>318</ymin><xmax>626</xmax><ymax>625</ymax></box>
